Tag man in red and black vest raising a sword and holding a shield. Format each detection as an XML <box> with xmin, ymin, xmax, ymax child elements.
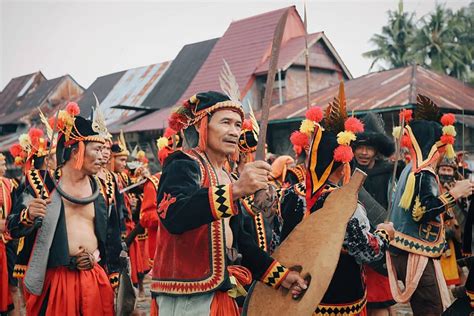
<box><xmin>151</xmin><ymin>91</ymin><xmax>306</xmax><ymax>315</ymax></box>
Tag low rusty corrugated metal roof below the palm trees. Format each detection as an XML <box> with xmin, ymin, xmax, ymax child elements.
<box><xmin>264</xmin><ymin>66</ymin><xmax>474</xmax><ymax>120</ymax></box>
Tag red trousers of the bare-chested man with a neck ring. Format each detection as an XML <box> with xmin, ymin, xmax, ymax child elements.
<box><xmin>26</xmin><ymin>264</ymin><xmax>115</xmax><ymax>316</ymax></box>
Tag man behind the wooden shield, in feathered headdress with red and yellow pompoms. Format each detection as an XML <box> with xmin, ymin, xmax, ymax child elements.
<box><xmin>283</xmin><ymin>83</ymin><xmax>393</xmax><ymax>315</ymax></box>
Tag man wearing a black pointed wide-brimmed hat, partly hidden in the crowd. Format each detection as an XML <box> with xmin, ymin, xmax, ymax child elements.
<box><xmin>352</xmin><ymin>113</ymin><xmax>403</xmax><ymax>316</ymax></box>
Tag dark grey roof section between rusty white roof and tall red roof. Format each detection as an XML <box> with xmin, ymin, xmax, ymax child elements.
<box><xmin>143</xmin><ymin>38</ymin><xmax>218</xmax><ymax>109</ymax></box>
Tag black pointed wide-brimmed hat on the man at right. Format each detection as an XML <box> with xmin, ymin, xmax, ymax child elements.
<box><xmin>353</xmin><ymin>113</ymin><xmax>395</xmax><ymax>157</ymax></box>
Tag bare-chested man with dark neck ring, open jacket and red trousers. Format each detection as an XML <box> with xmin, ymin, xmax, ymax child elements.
<box><xmin>8</xmin><ymin>103</ymin><xmax>121</xmax><ymax>315</ymax></box>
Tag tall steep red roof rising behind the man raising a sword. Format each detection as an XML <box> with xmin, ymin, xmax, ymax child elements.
<box><xmin>180</xmin><ymin>6</ymin><xmax>304</xmax><ymax>99</ymax></box>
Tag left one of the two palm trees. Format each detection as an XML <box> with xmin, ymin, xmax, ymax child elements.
<box><xmin>362</xmin><ymin>0</ymin><xmax>416</xmax><ymax>71</ymax></box>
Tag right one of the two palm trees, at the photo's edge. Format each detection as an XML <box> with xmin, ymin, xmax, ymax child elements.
<box><xmin>413</xmin><ymin>5</ymin><xmax>472</xmax><ymax>80</ymax></box>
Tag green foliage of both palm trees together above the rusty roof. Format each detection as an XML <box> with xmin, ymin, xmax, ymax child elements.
<box><xmin>363</xmin><ymin>1</ymin><xmax>474</xmax><ymax>83</ymax></box>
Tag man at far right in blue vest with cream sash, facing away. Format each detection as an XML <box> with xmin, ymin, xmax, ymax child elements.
<box><xmin>387</xmin><ymin>95</ymin><xmax>474</xmax><ymax>315</ymax></box>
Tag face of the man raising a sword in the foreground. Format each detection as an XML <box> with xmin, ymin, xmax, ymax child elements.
<box><xmin>207</xmin><ymin>110</ymin><xmax>242</xmax><ymax>156</ymax></box>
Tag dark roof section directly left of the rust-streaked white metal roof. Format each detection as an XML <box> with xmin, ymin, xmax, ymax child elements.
<box><xmin>78</xmin><ymin>71</ymin><xmax>125</xmax><ymax>117</ymax></box>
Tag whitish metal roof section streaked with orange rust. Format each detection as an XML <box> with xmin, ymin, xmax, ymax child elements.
<box><xmin>101</xmin><ymin>61</ymin><xmax>170</xmax><ymax>124</ymax></box>
